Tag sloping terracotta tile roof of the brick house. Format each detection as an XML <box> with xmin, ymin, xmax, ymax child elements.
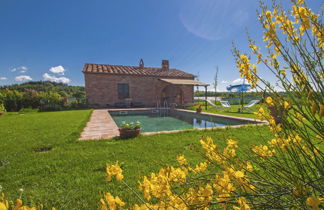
<box><xmin>82</xmin><ymin>63</ymin><xmax>195</xmax><ymax>79</ymax></box>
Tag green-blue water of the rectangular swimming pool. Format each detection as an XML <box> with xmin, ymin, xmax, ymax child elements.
<box><xmin>109</xmin><ymin>109</ymin><xmax>260</xmax><ymax>132</ymax></box>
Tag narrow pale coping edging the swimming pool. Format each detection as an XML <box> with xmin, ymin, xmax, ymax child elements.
<box><xmin>107</xmin><ymin>107</ymin><xmax>269</xmax><ymax>136</ymax></box>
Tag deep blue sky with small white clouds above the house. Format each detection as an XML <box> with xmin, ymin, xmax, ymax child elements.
<box><xmin>0</xmin><ymin>0</ymin><xmax>321</xmax><ymax>91</ymax></box>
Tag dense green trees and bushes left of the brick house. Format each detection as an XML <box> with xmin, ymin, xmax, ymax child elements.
<box><xmin>0</xmin><ymin>82</ymin><xmax>87</xmax><ymax>111</ymax></box>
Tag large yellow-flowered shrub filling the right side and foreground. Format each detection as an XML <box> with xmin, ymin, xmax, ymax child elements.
<box><xmin>100</xmin><ymin>0</ymin><xmax>324</xmax><ymax>209</ymax></box>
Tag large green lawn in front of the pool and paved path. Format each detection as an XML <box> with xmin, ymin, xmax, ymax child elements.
<box><xmin>0</xmin><ymin>110</ymin><xmax>271</xmax><ymax>209</ymax></box>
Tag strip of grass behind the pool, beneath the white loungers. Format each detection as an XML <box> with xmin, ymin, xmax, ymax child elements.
<box><xmin>188</xmin><ymin>102</ymin><xmax>261</xmax><ymax>119</ymax></box>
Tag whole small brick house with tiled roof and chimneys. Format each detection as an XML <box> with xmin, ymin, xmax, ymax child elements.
<box><xmin>83</xmin><ymin>60</ymin><xmax>197</xmax><ymax>108</ymax></box>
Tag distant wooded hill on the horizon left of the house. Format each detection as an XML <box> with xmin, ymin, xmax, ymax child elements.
<box><xmin>0</xmin><ymin>81</ymin><xmax>85</xmax><ymax>98</ymax></box>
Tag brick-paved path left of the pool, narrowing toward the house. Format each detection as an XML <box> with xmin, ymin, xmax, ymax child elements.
<box><xmin>79</xmin><ymin>109</ymin><xmax>119</xmax><ymax>140</ymax></box>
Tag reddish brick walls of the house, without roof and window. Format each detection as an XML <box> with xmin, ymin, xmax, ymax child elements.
<box><xmin>84</xmin><ymin>73</ymin><xmax>193</xmax><ymax>108</ymax></box>
